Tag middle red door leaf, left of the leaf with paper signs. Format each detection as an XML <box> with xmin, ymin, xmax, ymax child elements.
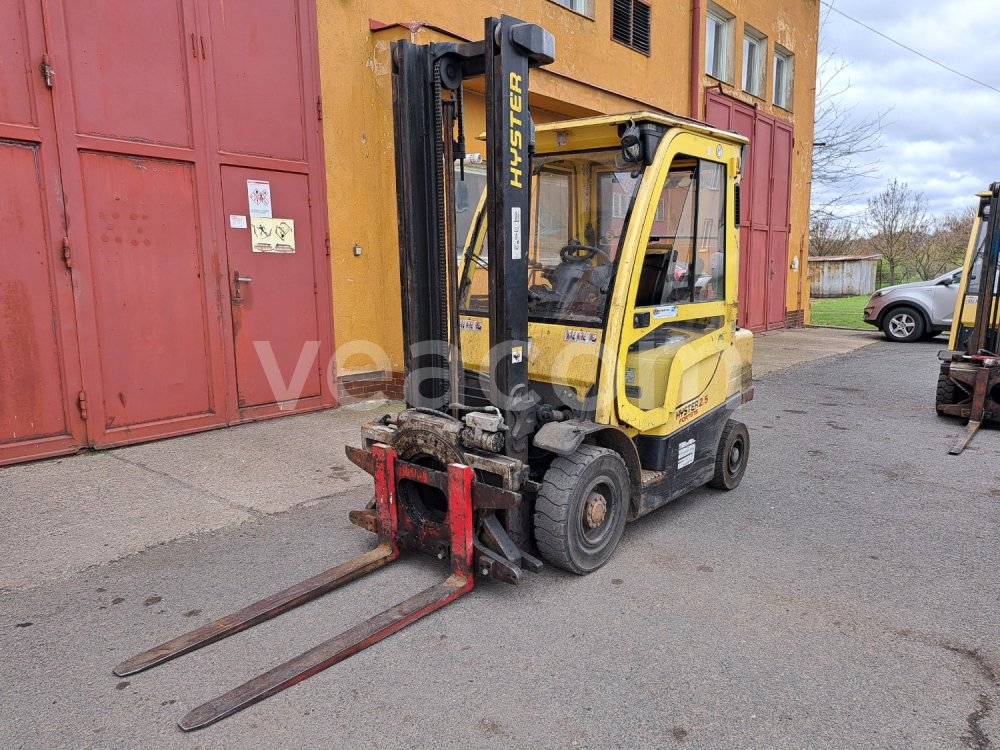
<box><xmin>50</xmin><ymin>0</ymin><xmax>227</xmax><ymax>446</ymax></box>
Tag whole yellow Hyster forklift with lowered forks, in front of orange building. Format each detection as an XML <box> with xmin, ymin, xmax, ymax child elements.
<box><xmin>114</xmin><ymin>16</ymin><xmax>753</xmax><ymax>730</ymax></box>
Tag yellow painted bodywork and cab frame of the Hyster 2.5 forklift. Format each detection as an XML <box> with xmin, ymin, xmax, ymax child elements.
<box><xmin>460</xmin><ymin>113</ymin><xmax>753</xmax><ymax>436</ymax></box>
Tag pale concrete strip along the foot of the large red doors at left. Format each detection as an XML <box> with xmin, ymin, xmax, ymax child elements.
<box><xmin>0</xmin><ymin>402</ymin><xmax>399</xmax><ymax>591</ymax></box>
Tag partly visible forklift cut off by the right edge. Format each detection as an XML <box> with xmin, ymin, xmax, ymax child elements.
<box><xmin>935</xmin><ymin>182</ymin><xmax>1000</xmax><ymax>455</ymax></box>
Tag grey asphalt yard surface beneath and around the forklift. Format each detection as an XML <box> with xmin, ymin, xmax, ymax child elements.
<box><xmin>0</xmin><ymin>341</ymin><xmax>1000</xmax><ymax>750</ymax></box>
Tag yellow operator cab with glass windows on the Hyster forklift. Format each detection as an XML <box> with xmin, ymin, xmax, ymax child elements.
<box><xmin>459</xmin><ymin>113</ymin><xmax>749</xmax><ymax>446</ymax></box>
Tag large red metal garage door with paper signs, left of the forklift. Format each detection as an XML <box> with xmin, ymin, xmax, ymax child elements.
<box><xmin>0</xmin><ymin>0</ymin><xmax>333</xmax><ymax>464</ymax></box>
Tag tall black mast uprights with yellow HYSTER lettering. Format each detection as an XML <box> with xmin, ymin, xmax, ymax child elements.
<box><xmin>392</xmin><ymin>16</ymin><xmax>555</xmax><ymax>460</ymax></box>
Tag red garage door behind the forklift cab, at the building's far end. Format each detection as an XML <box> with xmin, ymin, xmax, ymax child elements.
<box><xmin>705</xmin><ymin>91</ymin><xmax>792</xmax><ymax>331</ymax></box>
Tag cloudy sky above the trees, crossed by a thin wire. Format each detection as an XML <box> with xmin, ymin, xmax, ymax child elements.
<box><xmin>820</xmin><ymin>0</ymin><xmax>1000</xmax><ymax>223</ymax></box>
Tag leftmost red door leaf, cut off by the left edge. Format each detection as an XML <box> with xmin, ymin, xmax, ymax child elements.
<box><xmin>0</xmin><ymin>0</ymin><xmax>85</xmax><ymax>465</ymax></box>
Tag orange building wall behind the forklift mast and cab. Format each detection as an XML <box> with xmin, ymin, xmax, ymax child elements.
<box><xmin>317</xmin><ymin>0</ymin><xmax>819</xmax><ymax>384</ymax></box>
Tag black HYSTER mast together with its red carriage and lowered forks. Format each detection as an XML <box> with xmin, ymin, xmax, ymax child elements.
<box><xmin>114</xmin><ymin>16</ymin><xmax>555</xmax><ymax>730</ymax></box>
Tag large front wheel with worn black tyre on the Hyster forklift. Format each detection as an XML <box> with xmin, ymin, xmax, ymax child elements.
<box><xmin>534</xmin><ymin>445</ymin><xmax>630</xmax><ymax>575</ymax></box>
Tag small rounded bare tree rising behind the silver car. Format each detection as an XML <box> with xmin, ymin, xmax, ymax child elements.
<box><xmin>864</xmin><ymin>179</ymin><xmax>931</xmax><ymax>284</ymax></box>
